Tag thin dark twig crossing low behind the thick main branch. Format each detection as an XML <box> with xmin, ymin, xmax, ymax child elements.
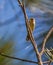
<box><xmin>0</xmin><ymin>52</ymin><xmax>50</xmax><ymax>64</ymax></box>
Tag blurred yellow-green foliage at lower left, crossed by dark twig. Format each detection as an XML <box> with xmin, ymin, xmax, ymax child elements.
<box><xmin>0</xmin><ymin>41</ymin><xmax>13</xmax><ymax>65</ymax></box>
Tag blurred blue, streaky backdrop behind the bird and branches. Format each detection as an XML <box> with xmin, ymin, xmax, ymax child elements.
<box><xmin>0</xmin><ymin>0</ymin><xmax>53</xmax><ymax>65</ymax></box>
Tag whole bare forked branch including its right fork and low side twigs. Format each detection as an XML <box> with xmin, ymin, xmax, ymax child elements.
<box><xmin>0</xmin><ymin>0</ymin><xmax>53</xmax><ymax>65</ymax></box>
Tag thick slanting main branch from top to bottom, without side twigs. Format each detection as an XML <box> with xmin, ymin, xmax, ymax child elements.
<box><xmin>18</xmin><ymin>0</ymin><xmax>43</xmax><ymax>65</ymax></box>
